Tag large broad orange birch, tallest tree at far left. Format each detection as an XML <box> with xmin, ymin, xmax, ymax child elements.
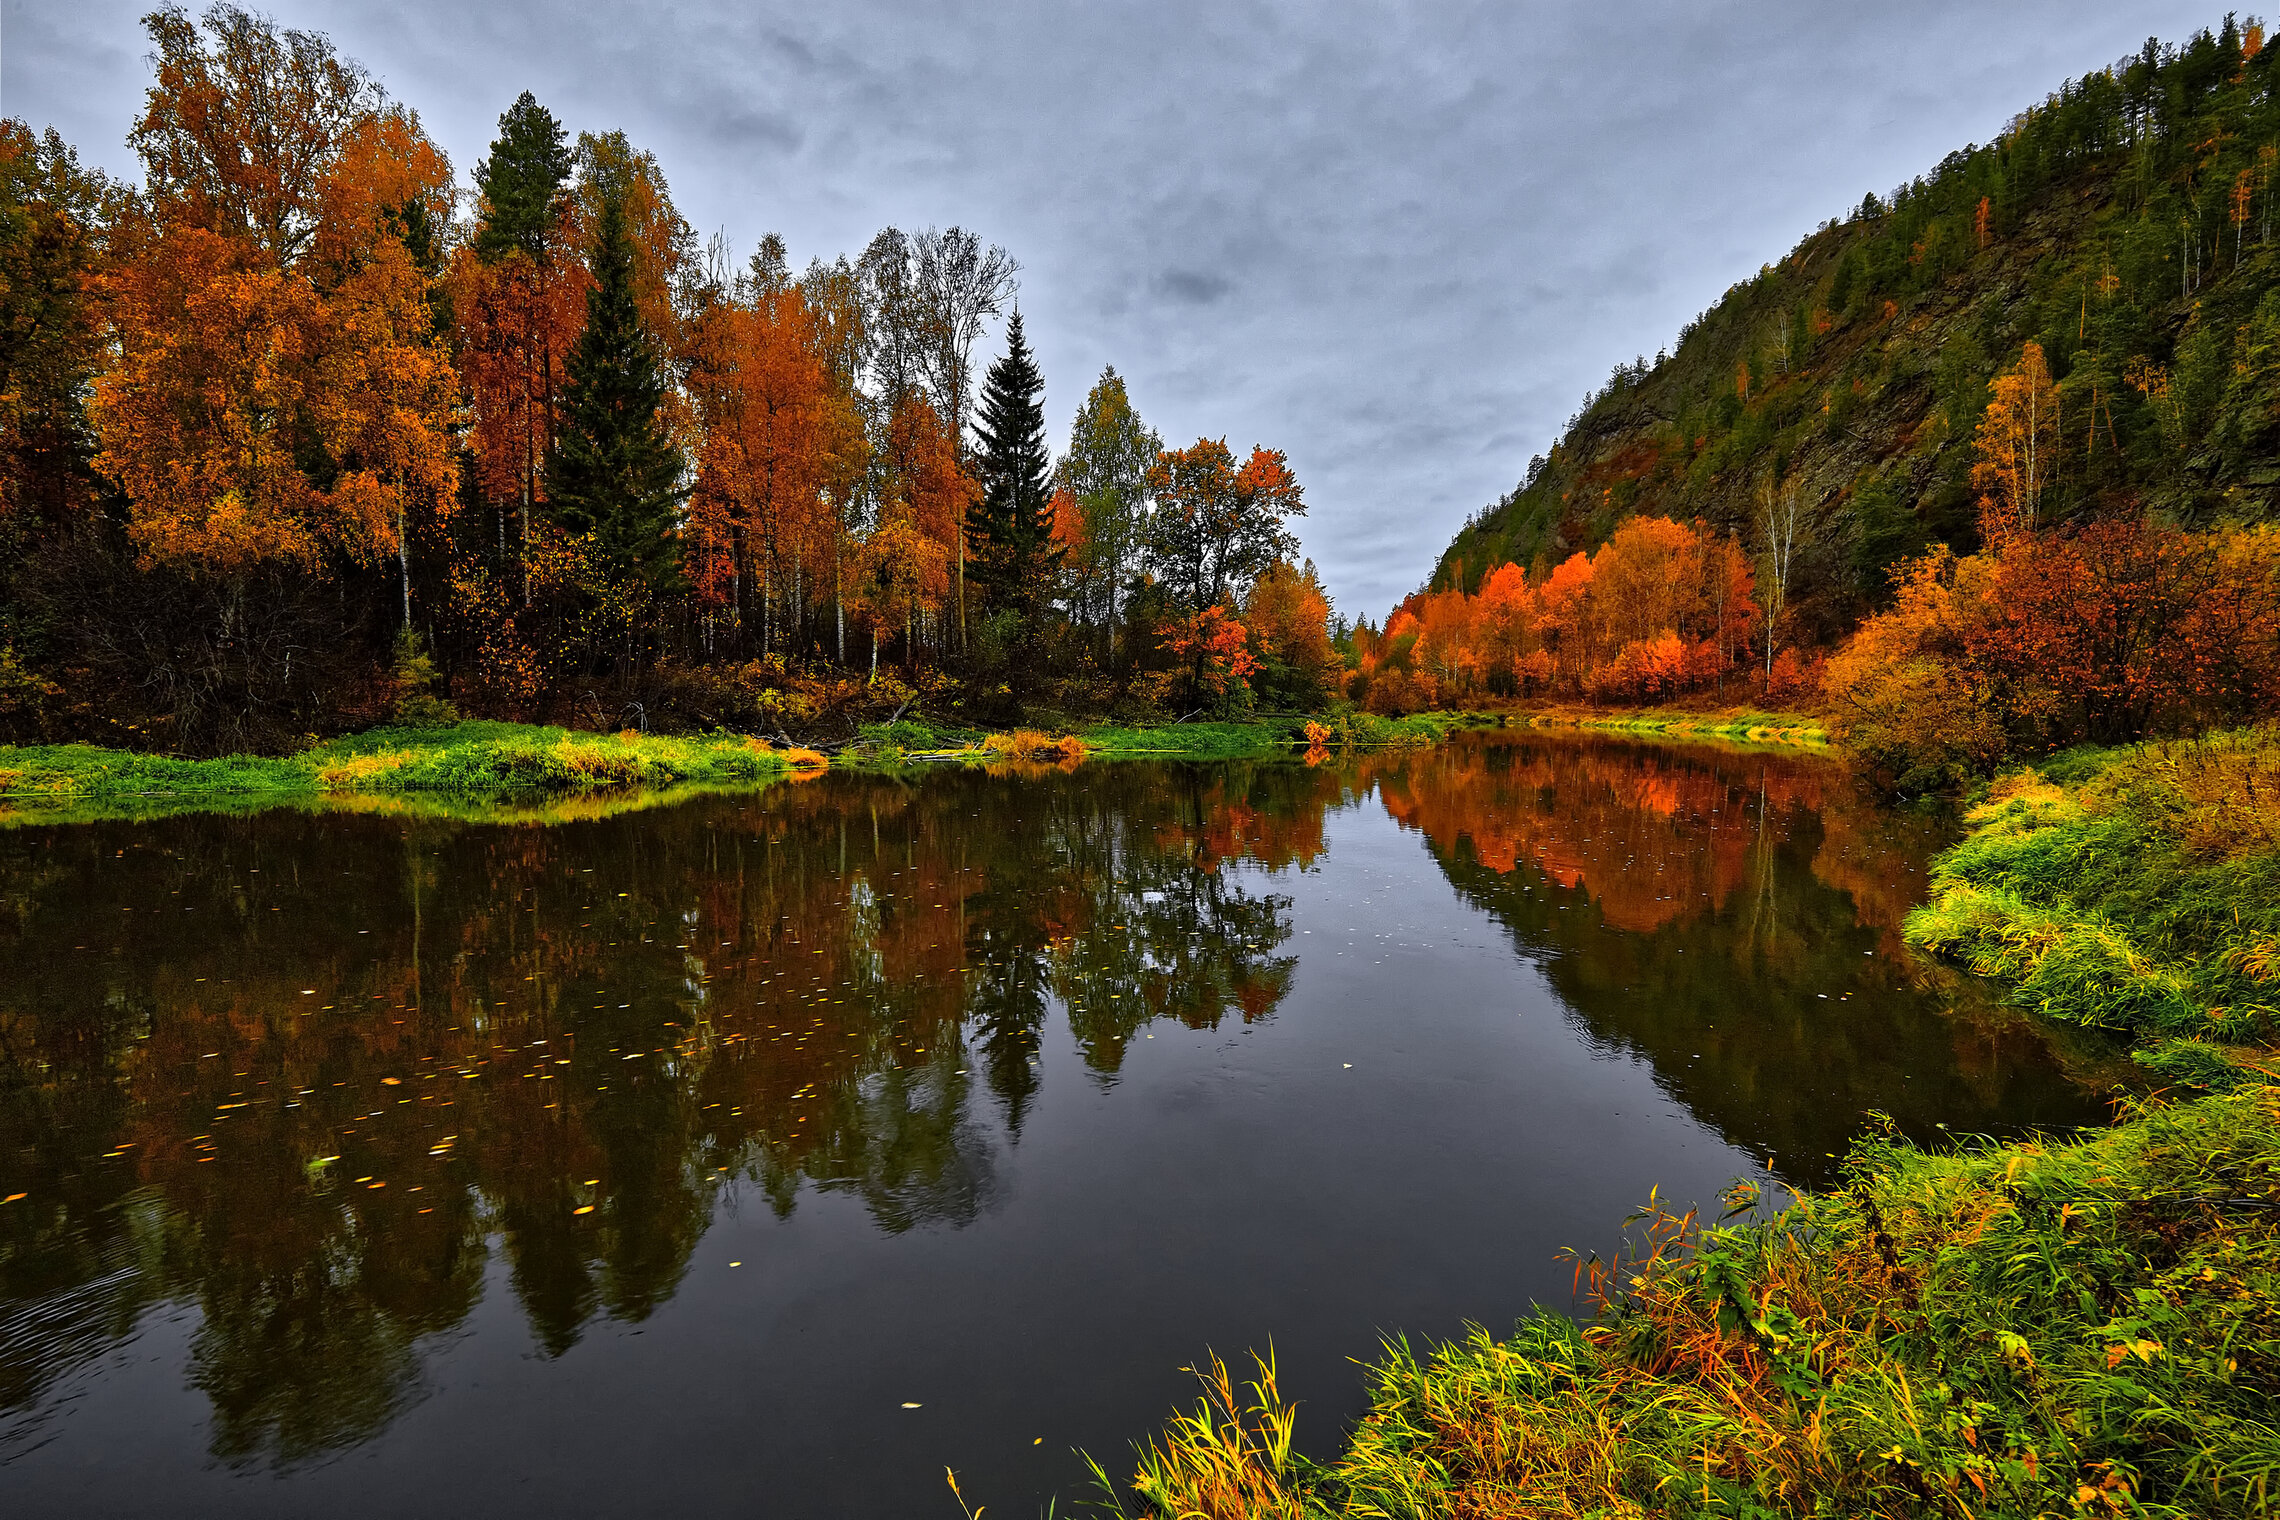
<box><xmin>89</xmin><ymin>7</ymin><xmax>456</xmax><ymax>592</ymax></box>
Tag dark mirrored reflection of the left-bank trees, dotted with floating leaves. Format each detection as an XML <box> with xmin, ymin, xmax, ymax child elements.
<box><xmin>0</xmin><ymin>766</ymin><xmax>1338</xmax><ymax>1463</ymax></box>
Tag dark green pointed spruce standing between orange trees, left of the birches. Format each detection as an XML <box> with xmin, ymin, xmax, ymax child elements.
<box><xmin>547</xmin><ymin>196</ymin><xmax>686</xmax><ymax>593</ymax></box>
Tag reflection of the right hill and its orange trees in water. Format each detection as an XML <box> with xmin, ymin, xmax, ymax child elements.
<box><xmin>1349</xmin><ymin>736</ymin><xmax>2118</xmax><ymax>1187</ymax></box>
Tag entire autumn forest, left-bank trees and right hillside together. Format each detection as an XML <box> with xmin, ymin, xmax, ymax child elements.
<box><xmin>0</xmin><ymin>5</ymin><xmax>2280</xmax><ymax>788</ymax></box>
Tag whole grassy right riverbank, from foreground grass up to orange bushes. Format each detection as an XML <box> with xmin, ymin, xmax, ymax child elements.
<box><xmin>1104</xmin><ymin>729</ymin><xmax>2280</xmax><ymax>1518</ymax></box>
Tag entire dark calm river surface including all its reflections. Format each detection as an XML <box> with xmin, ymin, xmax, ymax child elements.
<box><xmin>0</xmin><ymin>734</ymin><xmax>2104</xmax><ymax>1520</ymax></box>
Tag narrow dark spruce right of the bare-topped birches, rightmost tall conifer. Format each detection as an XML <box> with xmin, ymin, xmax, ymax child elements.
<box><xmin>967</xmin><ymin>312</ymin><xmax>1062</xmax><ymax>620</ymax></box>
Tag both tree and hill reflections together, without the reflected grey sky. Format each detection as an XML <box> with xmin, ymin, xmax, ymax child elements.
<box><xmin>0</xmin><ymin>736</ymin><xmax>2086</xmax><ymax>1465</ymax></box>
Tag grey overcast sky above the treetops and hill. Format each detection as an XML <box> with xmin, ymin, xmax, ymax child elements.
<box><xmin>0</xmin><ymin>0</ymin><xmax>2218</xmax><ymax>615</ymax></box>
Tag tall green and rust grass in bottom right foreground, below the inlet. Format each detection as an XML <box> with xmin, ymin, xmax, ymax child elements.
<box><xmin>1119</xmin><ymin>1087</ymin><xmax>2280</xmax><ymax>1520</ymax></box>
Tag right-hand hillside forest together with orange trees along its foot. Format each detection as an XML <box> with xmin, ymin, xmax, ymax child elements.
<box><xmin>1354</xmin><ymin>21</ymin><xmax>2280</xmax><ymax>788</ymax></box>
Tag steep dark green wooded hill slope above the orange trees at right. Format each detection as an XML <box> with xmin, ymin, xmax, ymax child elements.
<box><xmin>1432</xmin><ymin>16</ymin><xmax>2280</xmax><ymax>643</ymax></box>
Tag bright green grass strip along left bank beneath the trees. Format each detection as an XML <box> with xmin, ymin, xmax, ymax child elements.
<box><xmin>0</xmin><ymin>722</ymin><xmax>789</xmax><ymax>823</ymax></box>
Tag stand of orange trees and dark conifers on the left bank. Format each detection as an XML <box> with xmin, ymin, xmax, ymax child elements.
<box><xmin>0</xmin><ymin>5</ymin><xmax>1336</xmax><ymax>752</ymax></box>
